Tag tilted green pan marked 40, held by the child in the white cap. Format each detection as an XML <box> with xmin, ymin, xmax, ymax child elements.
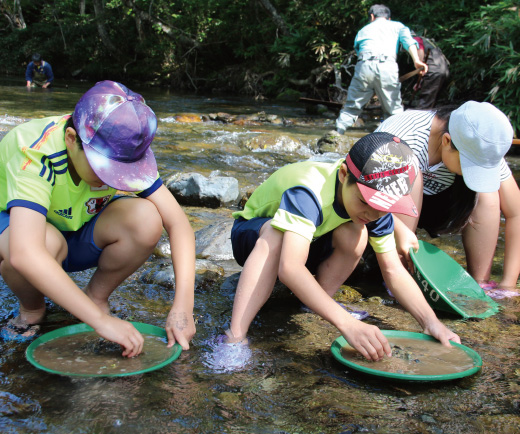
<box><xmin>410</xmin><ymin>241</ymin><xmax>500</xmax><ymax>318</ymax></box>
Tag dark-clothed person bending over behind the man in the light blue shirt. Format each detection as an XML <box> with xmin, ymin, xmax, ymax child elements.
<box><xmin>413</xmin><ymin>36</ymin><xmax>450</xmax><ymax>109</ymax></box>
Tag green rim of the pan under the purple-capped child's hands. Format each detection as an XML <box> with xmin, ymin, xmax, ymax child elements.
<box><xmin>25</xmin><ymin>322</ymin><xmax>182</xmax><ymax>377</ymax></box>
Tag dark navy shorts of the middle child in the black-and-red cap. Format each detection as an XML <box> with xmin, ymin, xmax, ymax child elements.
<box><xmin>231</xmin><ymin>217</ymin><xmax>334</xmax><ymax>274</ymax></box>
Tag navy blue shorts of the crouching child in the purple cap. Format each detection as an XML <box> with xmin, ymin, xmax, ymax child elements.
<box><xmin>0</xmin><ymin>196</ymin><xmax>124</xmax><ymax>272</ymax></box>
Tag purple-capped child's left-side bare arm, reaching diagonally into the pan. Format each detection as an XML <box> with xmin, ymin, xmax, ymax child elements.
<box><xmin>9</xmin><ymin>207</ymin><xmax>144</xmax><ymax>357</ymax></box>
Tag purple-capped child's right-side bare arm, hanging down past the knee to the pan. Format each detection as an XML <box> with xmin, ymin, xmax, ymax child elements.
<box><xmin>147</xmin><ymin>185</ymin><xmax>195</xmax><ymax>350</ymax></box>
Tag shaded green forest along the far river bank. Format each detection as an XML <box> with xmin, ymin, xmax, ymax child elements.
<box><xmin>0</xmin><ymin>0</ymin><xmax>520</xmax><ymax>133</ymax></box>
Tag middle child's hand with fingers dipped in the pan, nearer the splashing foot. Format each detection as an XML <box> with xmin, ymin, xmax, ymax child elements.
<box><xmin>343</xmin><ymin>320</ymin><xmax>392</xmax><ymax>362</ymax></box>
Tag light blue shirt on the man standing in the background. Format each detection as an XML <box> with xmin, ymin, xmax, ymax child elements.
<box><xmin>354</xmin><ymin>18</ymin><xmax>419</xmax><ymax>58</ymax></box>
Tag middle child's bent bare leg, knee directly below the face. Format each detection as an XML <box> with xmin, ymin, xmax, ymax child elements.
<box><xmin>316</xmin><ymin>223</ymin><xmax>368</xmax><ymax>297</ymax></box>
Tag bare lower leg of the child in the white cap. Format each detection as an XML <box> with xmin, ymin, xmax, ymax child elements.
<box><xmin>462</xmin><ymin>192</ymin><xmax>500</xmax><ymax>283</ymax></box>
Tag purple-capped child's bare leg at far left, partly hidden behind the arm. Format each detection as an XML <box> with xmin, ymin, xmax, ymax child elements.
<box><xmin>0</xmin><ymin>224</ymin><xmax>67</xmax><ymax>325</ymax></box>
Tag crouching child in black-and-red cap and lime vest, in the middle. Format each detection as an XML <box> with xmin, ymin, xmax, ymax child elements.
<box><xmin>226</xmin><ymin>133</ymin><xmax>460</xmax><ymax>360</ymax></box>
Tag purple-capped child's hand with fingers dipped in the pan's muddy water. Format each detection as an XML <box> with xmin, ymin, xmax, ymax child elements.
<box><xmin>95</xmin><ymin>315</ymin><xmax>144</xmax><ymax>357</ymax></box>
